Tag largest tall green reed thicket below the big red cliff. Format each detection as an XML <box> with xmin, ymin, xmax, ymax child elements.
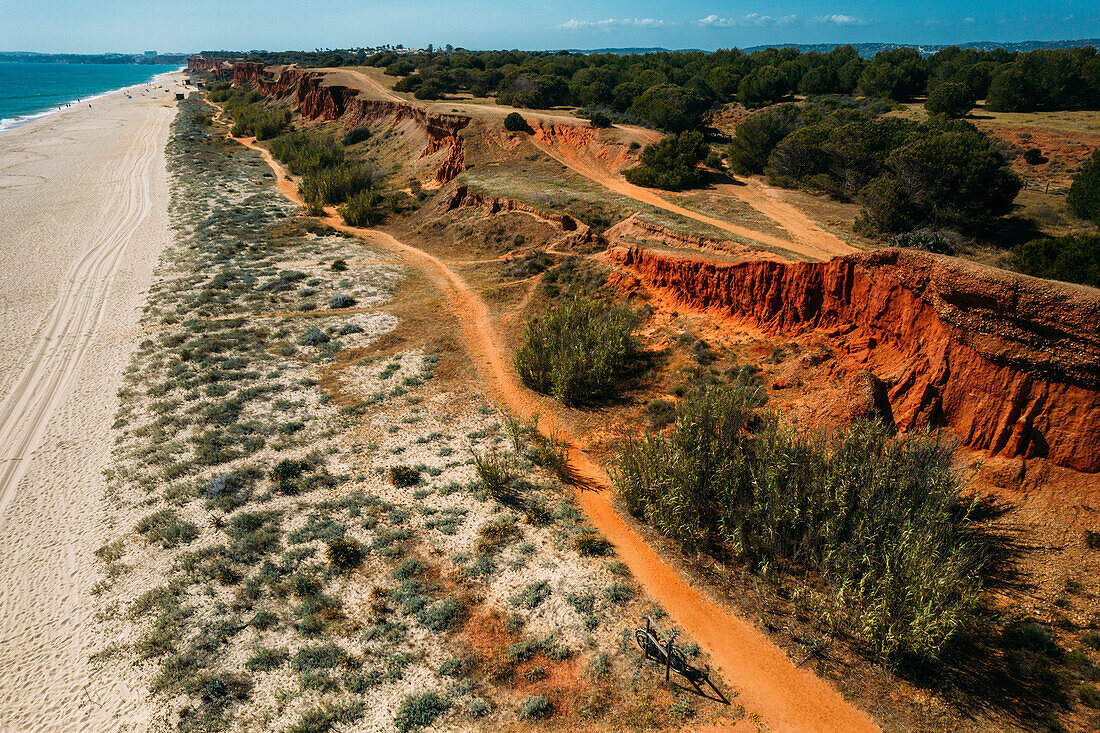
<box><xmin>614</xmin><ymin>387</ymin><xmax>985</xmax><ymax>658</ymax></box>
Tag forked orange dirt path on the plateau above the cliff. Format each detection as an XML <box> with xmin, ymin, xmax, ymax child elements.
<box><xmin>531</xmin><ymin>134</ymin><xmax>859</xmax><ymax>260</ymax></box>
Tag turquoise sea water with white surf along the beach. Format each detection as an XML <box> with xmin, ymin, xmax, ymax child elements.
<box><xmin>0</xmin><ymin>62</ymin><xmax>179</xmax><ymax>130</ymax></box>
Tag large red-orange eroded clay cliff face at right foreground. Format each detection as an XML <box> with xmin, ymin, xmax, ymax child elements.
<box><xmin>608</xmin><ymin>247</ymin><xmax>1100</xmax><ymax>472</ymax></box>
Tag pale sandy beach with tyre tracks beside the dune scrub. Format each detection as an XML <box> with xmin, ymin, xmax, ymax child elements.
<box><xmin>0</xmin><ymin>74</ymin><xmax>182</xmax><ymax>731</ymax></box>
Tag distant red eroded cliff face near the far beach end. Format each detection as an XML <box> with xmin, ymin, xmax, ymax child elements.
<box><xmin>233</xmin><ymin>62</ymin><xmax>470</xmax><ymax>184</ymax></box>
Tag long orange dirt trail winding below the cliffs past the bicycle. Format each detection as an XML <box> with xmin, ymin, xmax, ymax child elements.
<box><xmin>227</xmin><ymin>112</ymin><xmax>878</xmax><ymax>733</ymax></box>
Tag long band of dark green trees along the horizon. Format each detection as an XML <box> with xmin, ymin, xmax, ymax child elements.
<box><xmin>349</xmin><ymin>46</ymin><xmax>1100</xmax><ymax>127</ymax></box>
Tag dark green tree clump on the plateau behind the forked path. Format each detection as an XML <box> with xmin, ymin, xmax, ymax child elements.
<box><xmin>728</xmin><ymin>102</ymin><xmax>1021</xmax><ymax>233</ymax></box>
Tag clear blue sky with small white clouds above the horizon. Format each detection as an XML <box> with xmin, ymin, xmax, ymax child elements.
<box><xmin>0</xmin><ymin>0</ymin><xmax>1100</xmax><ymax>53</ymax></box>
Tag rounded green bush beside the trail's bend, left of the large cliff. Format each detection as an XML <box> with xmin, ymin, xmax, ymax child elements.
<box><xmin>515</xmin><ymin>296</ymin><xmax>639</xmax><ymax>405</ymax></box>
